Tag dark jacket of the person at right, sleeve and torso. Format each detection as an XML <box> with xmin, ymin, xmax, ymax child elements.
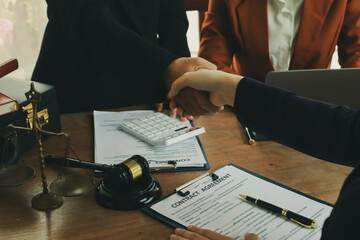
<box><xmin>234</xmin><ymin>78</ymin><xmax>360</xmax><ymax>240</ymax></box>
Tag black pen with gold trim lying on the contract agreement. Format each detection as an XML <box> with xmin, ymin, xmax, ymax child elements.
<box><xmin>240</xmin><ymin>194</ymin><xmax>317</xmax><ymax>228</ymax></box>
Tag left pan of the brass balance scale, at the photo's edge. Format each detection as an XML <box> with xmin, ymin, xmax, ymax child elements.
<box><xmin>0</xmin><ymin>165</ymin><xmax>35</xmax><ymax>187</ymax></box>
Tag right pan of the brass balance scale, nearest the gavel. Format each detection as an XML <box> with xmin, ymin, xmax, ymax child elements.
<box><xmin>50</xmin><ymin>174</ymin><xmax>96</xmax><ymax>197</ymax></box>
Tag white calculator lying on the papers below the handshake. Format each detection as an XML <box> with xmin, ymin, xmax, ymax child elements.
<box><xmin>120</xmin><ymin>112</ymin><xmax>205</xmax><ymax>145</ymax></box>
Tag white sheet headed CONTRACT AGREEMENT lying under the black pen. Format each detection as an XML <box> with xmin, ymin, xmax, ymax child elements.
<box><xmin>144</xmin><ymin>165</ymin><xmax>332</xmax><ymax>240</ymax></box>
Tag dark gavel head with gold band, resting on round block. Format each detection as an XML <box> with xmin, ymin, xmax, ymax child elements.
<box><xmin>103</xmin><ymin>155</ymin><xmax>149</xmax><ymax>190</ymax></box>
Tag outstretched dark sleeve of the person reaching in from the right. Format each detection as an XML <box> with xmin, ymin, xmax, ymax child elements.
<box><xmin>234</xmin><ymin>78</ymin><xmax>360</xmax><ymax>166</ymax></box>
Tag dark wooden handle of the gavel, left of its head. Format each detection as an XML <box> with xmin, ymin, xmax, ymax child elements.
<box><xmin>44</xmin><ymin>155</ymin><xmax>115</xmax><ymax>172</ymax></box>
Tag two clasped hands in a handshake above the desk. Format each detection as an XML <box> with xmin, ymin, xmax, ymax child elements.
<box><xmin>162</xmin><ymin>58</ymin><xmax>243</xmax><ymax>121</ymax></box>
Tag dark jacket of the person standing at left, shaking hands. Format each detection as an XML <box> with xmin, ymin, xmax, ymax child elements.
<box><xmin>32</xmin><ymin>0</ymin><xmax>190</xmax><ymax>113</ymax></box>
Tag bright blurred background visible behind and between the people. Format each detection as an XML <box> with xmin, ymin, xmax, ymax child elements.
<box><xmin>0</xmin><ymin>0</ymin><xmax>339</xmax><ymax>80</ymax></box>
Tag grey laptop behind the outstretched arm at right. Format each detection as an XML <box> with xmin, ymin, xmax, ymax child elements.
<box><xmin>265</xmin><ymin>68</ymin><xmax>360</xmax><ymax>110</ymax></box>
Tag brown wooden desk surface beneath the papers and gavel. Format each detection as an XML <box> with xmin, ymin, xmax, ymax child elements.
<box><xmin>0</xmin><ymin>109</ymin><xmax>351</xmax><ymax>240</ymax></box>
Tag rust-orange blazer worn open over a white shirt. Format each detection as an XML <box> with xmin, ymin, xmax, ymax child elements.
<box><xmin>199</xmin><ymin>0</ymin><xmax>360</xmax><ymax>81</ymax></box>
